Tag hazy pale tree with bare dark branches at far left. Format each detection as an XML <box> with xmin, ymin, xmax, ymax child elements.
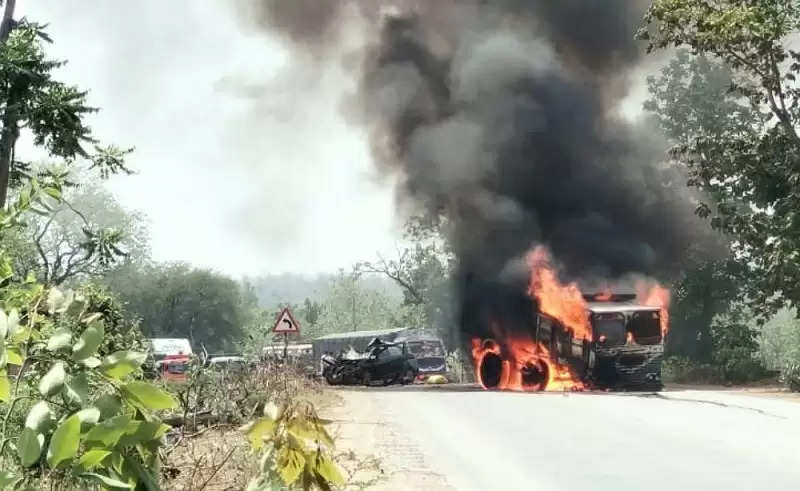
<box><xmin>27</xmin><ymin>183</ymin><xmax>149</xmax><ymax>285</ymax></box>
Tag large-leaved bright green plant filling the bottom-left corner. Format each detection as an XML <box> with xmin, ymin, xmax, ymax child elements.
<box><xmin>0</xmin><ymin>284</ymin><xmax>177</xmax><ymax>491</ymax></box>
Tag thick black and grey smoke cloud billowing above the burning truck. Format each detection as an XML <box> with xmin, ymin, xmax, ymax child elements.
<box><xmin>236</xmin><ymin>0</ymin><xmax>712</xmax><ymax>338</ymax></box>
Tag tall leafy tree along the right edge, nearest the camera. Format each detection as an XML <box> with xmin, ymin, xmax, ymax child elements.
<box><xmin>638</xmin><ymin>0</ymin><xmax>800</xmax><ymax>319</ymax></box>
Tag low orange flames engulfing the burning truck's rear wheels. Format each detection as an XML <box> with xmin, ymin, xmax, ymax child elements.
<box><xmin>472</xmin><ymin>330</ymin><xmax>585</xmax><ymax>392</ymax></box>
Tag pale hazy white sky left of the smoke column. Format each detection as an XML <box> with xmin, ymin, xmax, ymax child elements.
<box><xmin>17</xmin><ymin>0</ymin><xmax>399</xmax><ymax>275</ymax></box>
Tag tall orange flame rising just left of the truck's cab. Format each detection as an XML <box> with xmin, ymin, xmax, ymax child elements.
<box><xmin>527</xmin><ymin>246</ymin><xmax>592</xmax><ymax>340</ymax></box>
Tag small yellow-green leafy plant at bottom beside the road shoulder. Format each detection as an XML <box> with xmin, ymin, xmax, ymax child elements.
<box><xmin>242</xmin><ymin>401</ymin><xmax>345</xmax><ymax>491</ymax></box>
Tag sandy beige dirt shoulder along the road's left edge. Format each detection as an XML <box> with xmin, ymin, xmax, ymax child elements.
<box><xmin>322</xmin><ymin>389</ymin><xmax>455</xmax><ymax>491</ymax></box>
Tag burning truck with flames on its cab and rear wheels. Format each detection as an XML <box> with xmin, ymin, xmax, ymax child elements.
<box><xmin>472</xmin><ymin>247</ymin><xmax>669</xmax><ymax>391</ymax></box>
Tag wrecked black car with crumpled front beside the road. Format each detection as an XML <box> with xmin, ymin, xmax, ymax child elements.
<box><xmin>322</xmin><ymin>339</ymin><xmax>419</xmax><ymax>386</ymax></box>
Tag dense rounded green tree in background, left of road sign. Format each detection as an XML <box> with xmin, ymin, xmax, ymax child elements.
<box><xmin>103</xmin><ymin>263</ymin><xmax>250</xmax><ymax>351</ymax></box>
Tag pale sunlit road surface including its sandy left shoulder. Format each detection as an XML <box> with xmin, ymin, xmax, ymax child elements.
<box><xmin>326</xmin><ymin>386</ymin><xmax>800</xmax><ymax>491</ymax></box>
